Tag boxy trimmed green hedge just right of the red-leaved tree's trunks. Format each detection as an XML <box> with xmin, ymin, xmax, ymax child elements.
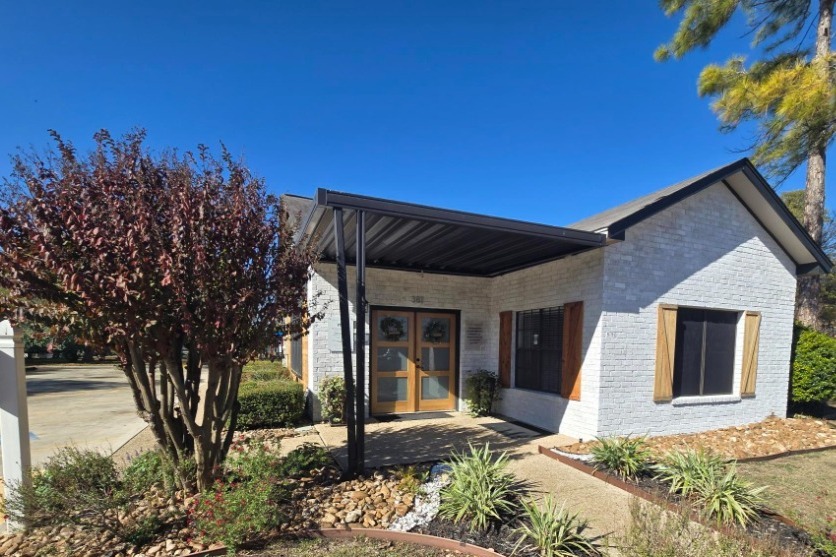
<box><xmin>238</xmin><ymin>381</ymin><xmax>305</xmax><ymax>430</ymax></box>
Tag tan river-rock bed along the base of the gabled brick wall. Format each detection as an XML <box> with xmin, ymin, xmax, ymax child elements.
<box><xmin>559</xmin><ymin>417</ymin><xmax>836</xmax><ymax>460</ymax></box>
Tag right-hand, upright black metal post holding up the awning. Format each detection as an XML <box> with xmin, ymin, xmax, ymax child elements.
<box><xmin>354</xmin><ymin>211</ymin><xmax>366</xmax><ymax>474</ymax></box>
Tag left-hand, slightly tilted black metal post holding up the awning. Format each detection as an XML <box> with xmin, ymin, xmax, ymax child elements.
<box><xmin>334</xmin><ymin>207</ymin><xmax>357</xmax><ymax>478</ymax></box>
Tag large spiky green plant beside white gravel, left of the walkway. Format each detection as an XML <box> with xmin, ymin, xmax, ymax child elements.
<box><xmin>439</xmin><ymin>443</ymin><xmax>520</xmax><ymax>531</ymax></box>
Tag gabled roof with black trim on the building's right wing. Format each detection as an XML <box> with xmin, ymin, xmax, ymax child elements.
<box><xmin>570</xmin><ymin>158</ymin><xmax>833</xmax><ymax>274</ymax></box>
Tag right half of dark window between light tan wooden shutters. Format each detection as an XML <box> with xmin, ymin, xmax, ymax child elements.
<box><xmin>702</xmin><ymin>311</ymin><xmax>737</xmax><ymax>395</ymax></box>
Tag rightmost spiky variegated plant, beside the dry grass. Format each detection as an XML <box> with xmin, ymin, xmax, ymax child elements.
<box><xmin>694</xmin><ymin>466</ymin><xmax>766</xmax><ymax>526</ymax></box>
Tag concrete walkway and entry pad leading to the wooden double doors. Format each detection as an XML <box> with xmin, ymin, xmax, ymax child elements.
<box><xmin>316</xmin><ymin>412</ymin><xmax>632</xmax><ymax>537</ymax></box>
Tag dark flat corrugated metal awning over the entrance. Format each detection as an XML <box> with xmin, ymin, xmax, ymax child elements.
<box><xmin>300</xmin><ymin>189</ymin><xmax>606</xmax><ymax>277</ymax></box>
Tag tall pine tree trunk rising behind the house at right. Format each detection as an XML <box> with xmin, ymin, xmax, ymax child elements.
<box><xmin>795</xmin><ymin>0</ymin><xmax>834</xmax><ymax>329</ymax></box>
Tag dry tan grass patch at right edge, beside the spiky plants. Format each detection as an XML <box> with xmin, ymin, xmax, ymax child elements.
<box><xmin>738</xmin><ymin>449</ymin><xmax>836</xmax><ymax>534</ymax></box>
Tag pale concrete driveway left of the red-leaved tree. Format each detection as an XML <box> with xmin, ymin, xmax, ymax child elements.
<box><xmin>0</xmin><ymin>364</ymin><xmax>146</xmax><ymax>473</ymax></box>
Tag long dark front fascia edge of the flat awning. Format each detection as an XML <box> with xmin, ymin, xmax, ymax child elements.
<box><xmin>316</xmin><ymin>189</ymin><xmax>606</xmax><ymax>246</ymax></box>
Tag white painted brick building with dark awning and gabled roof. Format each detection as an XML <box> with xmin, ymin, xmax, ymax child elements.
<box><xmin>288</xmin><ymin>159</ymin><xmax>830</xmax><ymax>439</ymax></box>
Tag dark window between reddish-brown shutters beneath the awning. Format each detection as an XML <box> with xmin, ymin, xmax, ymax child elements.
<box><xmin>513</xmin><ymin>305</ymin><xmax>565</xmax><ymax>396</ymax></box>
